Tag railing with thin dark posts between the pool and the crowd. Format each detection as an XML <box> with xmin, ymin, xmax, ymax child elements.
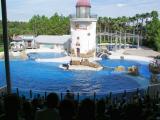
<box><xmin>10</xmin><ymin>84</ymin><xmax>160</xmax><ymax>102</ymax></box>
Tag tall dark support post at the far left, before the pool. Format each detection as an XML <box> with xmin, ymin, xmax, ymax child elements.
<box><xmin>1</xmin><ymin>0</ymin><xmax>11</xmax><ymax>94</ymax></box>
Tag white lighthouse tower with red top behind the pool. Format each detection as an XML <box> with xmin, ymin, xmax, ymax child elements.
<box><xmin>70</xmin><ymin>0</ymin><xmax>97</xmax><ymax>57</ymax></box>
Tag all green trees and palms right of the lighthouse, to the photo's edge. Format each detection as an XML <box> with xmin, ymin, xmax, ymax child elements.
<box><xmin>97</xmin><ymin>11</ymin><xmax>160</xmax><ymax>51</ymax></box>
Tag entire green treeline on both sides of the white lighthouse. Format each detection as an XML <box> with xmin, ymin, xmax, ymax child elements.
<box><xmin>0</xmin><ymin>11</ymin><xmax>160</xmax><ymax>51</ymax></box>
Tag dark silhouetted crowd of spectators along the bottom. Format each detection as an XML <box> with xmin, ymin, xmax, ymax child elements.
<box><xmin>0</xmin><ymin>92</ymin><xmax>160</xmax><ymax>120</ymax></box>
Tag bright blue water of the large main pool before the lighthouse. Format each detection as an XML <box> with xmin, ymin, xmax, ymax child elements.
<box><xmin>0</xmin><ymin>60</ymin><xmax>150</xmax><ymax>93</ymax></box>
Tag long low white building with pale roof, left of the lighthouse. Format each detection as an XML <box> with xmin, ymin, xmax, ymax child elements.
<box><xmin>35</xmin><ymin>35</ymin><xmax>71</xmax><ymax>52</ymax></box>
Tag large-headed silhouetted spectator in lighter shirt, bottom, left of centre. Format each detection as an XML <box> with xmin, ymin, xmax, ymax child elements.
<box><xmin>35</xmin><ymin>93</ymin><xmax>60</xmax><ymax>120</ymax></box>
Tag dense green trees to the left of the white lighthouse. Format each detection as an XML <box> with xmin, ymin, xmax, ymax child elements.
<box><xmin>0</xmin><ymin>13</ymin><xmax>70</xmax><ymax>37</ymax></box>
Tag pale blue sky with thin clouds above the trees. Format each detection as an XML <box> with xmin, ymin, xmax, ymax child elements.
<box><xmin>0</xmin><ymin>0</ymin><xmax>160</xmax><ymax>21</ymax></box>
